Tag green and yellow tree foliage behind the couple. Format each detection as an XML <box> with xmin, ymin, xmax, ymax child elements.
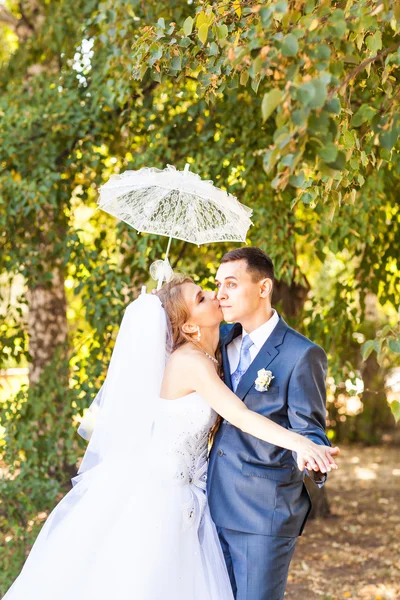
<box><xmin>0</xmin><ymin>0</ymin><xmax>400</xmax><ymax>590</ymax></box>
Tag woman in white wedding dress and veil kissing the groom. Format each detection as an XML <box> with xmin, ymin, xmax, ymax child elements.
<box><xmin>3</xmin><ymin>276</ymin><xmax>336</xmax><ymax>600</ymax></box>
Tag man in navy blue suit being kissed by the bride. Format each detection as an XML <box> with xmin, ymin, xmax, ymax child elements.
<box><xmin>208</xmin><ymin>247</ymin><xmax>330</xmax><ymax>600</ymax></box>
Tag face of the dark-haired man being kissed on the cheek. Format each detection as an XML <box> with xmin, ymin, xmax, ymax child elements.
<box><xmin>215</xmin><ymin>259</ymin><xmax>263</xmax><ymax>323</ymax></box>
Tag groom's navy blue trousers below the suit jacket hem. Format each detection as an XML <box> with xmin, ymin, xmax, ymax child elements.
<box><xmin>217</xmin><ymin>527</ymin><xmax>297</xmax><ymax>600</ymax></box>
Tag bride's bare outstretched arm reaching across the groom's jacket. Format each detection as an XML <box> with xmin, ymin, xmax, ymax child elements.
<box><xmin>181</xmin><ymin>354</ymin><xmax>338</xmax><ymax>473</ymax></box>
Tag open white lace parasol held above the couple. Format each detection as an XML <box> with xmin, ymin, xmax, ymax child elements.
<box><xmin>98</xmin><ymin>164</ymin><xmax>253</xmax><ymax>285</ymax></box>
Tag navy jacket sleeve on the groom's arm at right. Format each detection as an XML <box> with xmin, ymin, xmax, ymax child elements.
<box><xmin>288</xmin><ymin>345</ymin><xmax>331</xmax><ymax>484</ymax></box>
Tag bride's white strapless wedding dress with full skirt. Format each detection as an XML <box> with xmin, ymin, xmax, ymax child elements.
<box><xmin>3</xmin><ymin>292</ymin><xmax>233</xmax><ymax>600</ymax></box>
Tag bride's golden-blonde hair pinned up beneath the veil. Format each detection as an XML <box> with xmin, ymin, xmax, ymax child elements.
<box><xmin>156</xmin><ymin>274</ymin><xmax>199</xmax><ymax>352</ymax></box>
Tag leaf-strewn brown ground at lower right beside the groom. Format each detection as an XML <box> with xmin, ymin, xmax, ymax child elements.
<box><xmin>285</xmin><ymin>446</ymin><xmax>400</xmax><ymax>600</ymax></box>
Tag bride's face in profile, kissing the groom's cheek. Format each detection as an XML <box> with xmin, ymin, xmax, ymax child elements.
<box><xmin>182</xmin><ymin>283</ymin><xmax>224</xmax><ymax>328</ymax></box>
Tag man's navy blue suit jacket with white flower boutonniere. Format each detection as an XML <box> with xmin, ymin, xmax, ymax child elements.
<box><xmin>207</xmin><ymin>317</ymin><xmax>330</xmax><ymax>537</ymax></box>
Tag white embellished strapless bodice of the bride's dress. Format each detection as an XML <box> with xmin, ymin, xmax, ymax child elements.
<box><xmin>152</xmin><ymin>392</ymin><xmax>217</xmax><ymax>526</ymax></box>
